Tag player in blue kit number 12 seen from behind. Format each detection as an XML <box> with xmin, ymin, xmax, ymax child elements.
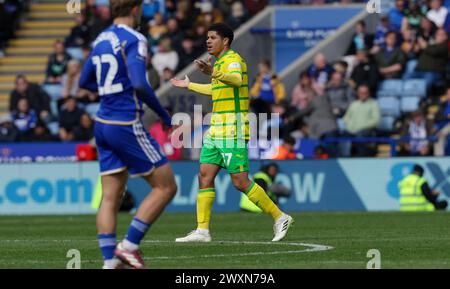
<box><xmin>80</xmin><ymin>0</ymin><xmax>177</xmax><ymax>269</ymax></box>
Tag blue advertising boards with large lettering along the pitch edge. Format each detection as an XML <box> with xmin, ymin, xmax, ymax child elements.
<box><xmin>0</xmin><ymin>157</ymin><xmax>450</xmax><ymax>215</ymax></box>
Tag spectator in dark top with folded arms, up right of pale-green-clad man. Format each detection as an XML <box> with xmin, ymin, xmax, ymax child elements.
<box><xmin>375</xmin><ymin>31</ymin><xmax>406</xmax><ymax>79</ymax></box>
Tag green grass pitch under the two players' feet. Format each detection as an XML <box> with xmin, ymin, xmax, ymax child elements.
<box><xmin>0</xmin><ymin>212</ymin><xmax>450</xmax><ymax>269</ymax></box>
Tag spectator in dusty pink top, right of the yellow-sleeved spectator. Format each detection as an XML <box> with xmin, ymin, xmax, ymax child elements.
<box><xmin>291</xmin><ymin>71</ymin><xmax>324</xmax><ymax>109</ymax></box>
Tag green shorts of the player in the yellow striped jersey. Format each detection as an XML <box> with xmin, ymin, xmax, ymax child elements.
<box><xmin>200</xmin><ymin>134</ymin><xmax>249</xmax><ymax>174</ymax></box>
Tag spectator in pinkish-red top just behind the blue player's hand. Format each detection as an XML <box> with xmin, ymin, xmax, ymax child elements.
<box><xmin>149</xmin><ymin>107</ymin><xmax>183</xmax><ymax>160</ymax></box>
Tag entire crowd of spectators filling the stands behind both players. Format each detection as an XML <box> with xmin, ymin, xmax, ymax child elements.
<box><xmin>0</xmin><ymin>0</ymin><xmax>450</xmax><ymax>159</ymax></box>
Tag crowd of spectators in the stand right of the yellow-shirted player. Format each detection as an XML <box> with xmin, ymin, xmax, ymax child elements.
<box><xmin>251</xmin><ymin>0</ymin><xmax>450</xmax><ymax>158</ymax></box>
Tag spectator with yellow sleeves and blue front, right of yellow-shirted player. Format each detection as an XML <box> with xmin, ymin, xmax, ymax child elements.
<box><xmin>250</xmin><ymin>60</ymin><xmax>286</xmax><ymax>114</ymax></box>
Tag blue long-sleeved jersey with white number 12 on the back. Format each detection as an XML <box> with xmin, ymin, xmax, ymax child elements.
<box><xmin>80</xmin><ymin>24</ymin><xmax>170</xmax><ymax>125</ymax></box>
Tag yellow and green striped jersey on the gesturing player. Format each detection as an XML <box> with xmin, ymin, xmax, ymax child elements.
<box><xmin>209</xmin><ymin>50</ymin><xmax>250</xmax><ymax>140</ymax></box>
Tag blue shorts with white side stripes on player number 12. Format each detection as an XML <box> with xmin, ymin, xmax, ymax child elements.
<box><xmin>95</xmin><ymin>121</ymin><xmax>167</xmax><ymax>176</ymax></box>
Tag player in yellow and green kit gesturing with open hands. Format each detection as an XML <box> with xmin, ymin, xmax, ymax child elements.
<box><xmin>171</xmin><ymin>23</ymin><xmax>294</xmax><ymax>242</ymax></box>
